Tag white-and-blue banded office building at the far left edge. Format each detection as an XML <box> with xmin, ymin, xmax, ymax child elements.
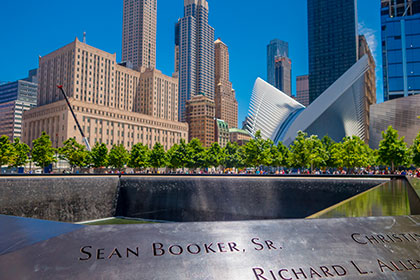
<box><xmin>0</xmin><ymin>78</ymin><xmax>38</xmax><ymax>139</ymax></box>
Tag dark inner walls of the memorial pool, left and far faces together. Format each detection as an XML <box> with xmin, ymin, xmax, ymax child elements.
<box><xmin>0</xmin><ymin>176</ymin><xmax>390</xmax><ymax>222</ymax></box>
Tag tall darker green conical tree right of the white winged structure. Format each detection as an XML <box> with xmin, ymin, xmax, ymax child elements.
<box><xmin>378</xmin><ymin>126</ymin><xmax>410</xmax><ymax>172</ymax></box>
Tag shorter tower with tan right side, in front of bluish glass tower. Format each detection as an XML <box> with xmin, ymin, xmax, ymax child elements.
<box><xmin>274</xmin><ymin>56</ymin><xmax>292</xmax><ymax>96</ymax></box>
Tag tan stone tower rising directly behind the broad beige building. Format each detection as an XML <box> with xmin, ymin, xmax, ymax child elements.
<box><xmin>122</xmin><ymin>0</ymin><xmax>157</xmax><ymax>69</ymax></box>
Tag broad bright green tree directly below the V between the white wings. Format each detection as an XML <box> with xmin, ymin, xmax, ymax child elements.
<box><xmin>289</xmin><ymin>131</ymin><xmax>328</xmax><ymax>170</ymax></box>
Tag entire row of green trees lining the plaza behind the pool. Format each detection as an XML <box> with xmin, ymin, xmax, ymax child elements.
<box><xmin>0</xmin><ymin>127</ymin><xmax>420</xmax><ymax>171</ymax></box>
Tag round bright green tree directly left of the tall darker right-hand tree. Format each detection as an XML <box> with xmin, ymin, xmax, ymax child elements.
<box><xmin>333</xmin><ymin>136</ymin><xmax>372</xmax><ymax>172</ymax></box>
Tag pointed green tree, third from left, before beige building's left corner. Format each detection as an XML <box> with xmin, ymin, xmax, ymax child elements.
<box><xmin>31</xmin><ymin>131</ymin><xmax>57</xmax><ymax>171</ymax></box>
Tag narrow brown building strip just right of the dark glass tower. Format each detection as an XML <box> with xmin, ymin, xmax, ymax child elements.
<box><xmin>359</xmin><ymin>35</ymin><xmax>376</xmax><ymax>143</ymax></box>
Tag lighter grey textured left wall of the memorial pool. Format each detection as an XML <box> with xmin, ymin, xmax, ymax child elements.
<box><xmin>0</xmin><ymin>176</ymin><xmax>119</xmax><ymax>222</ymax></box>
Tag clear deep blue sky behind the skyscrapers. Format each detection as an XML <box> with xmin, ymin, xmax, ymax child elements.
<box><xmin>0</xmin><ymin>0</ymin><xmax>383</xmax><ymax>126</ymax></box>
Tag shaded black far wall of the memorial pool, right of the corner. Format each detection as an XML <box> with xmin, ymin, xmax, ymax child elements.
<box><xmin>117</xmin><ymin>177</ymin><xmax>384</xmax><ymax>222</ymax></box>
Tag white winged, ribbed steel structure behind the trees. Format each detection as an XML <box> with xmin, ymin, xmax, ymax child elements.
<box><xmin>246</xmin><ymin>55</ymin><xmax>369</xmax><ymax>145</ymax></box>
